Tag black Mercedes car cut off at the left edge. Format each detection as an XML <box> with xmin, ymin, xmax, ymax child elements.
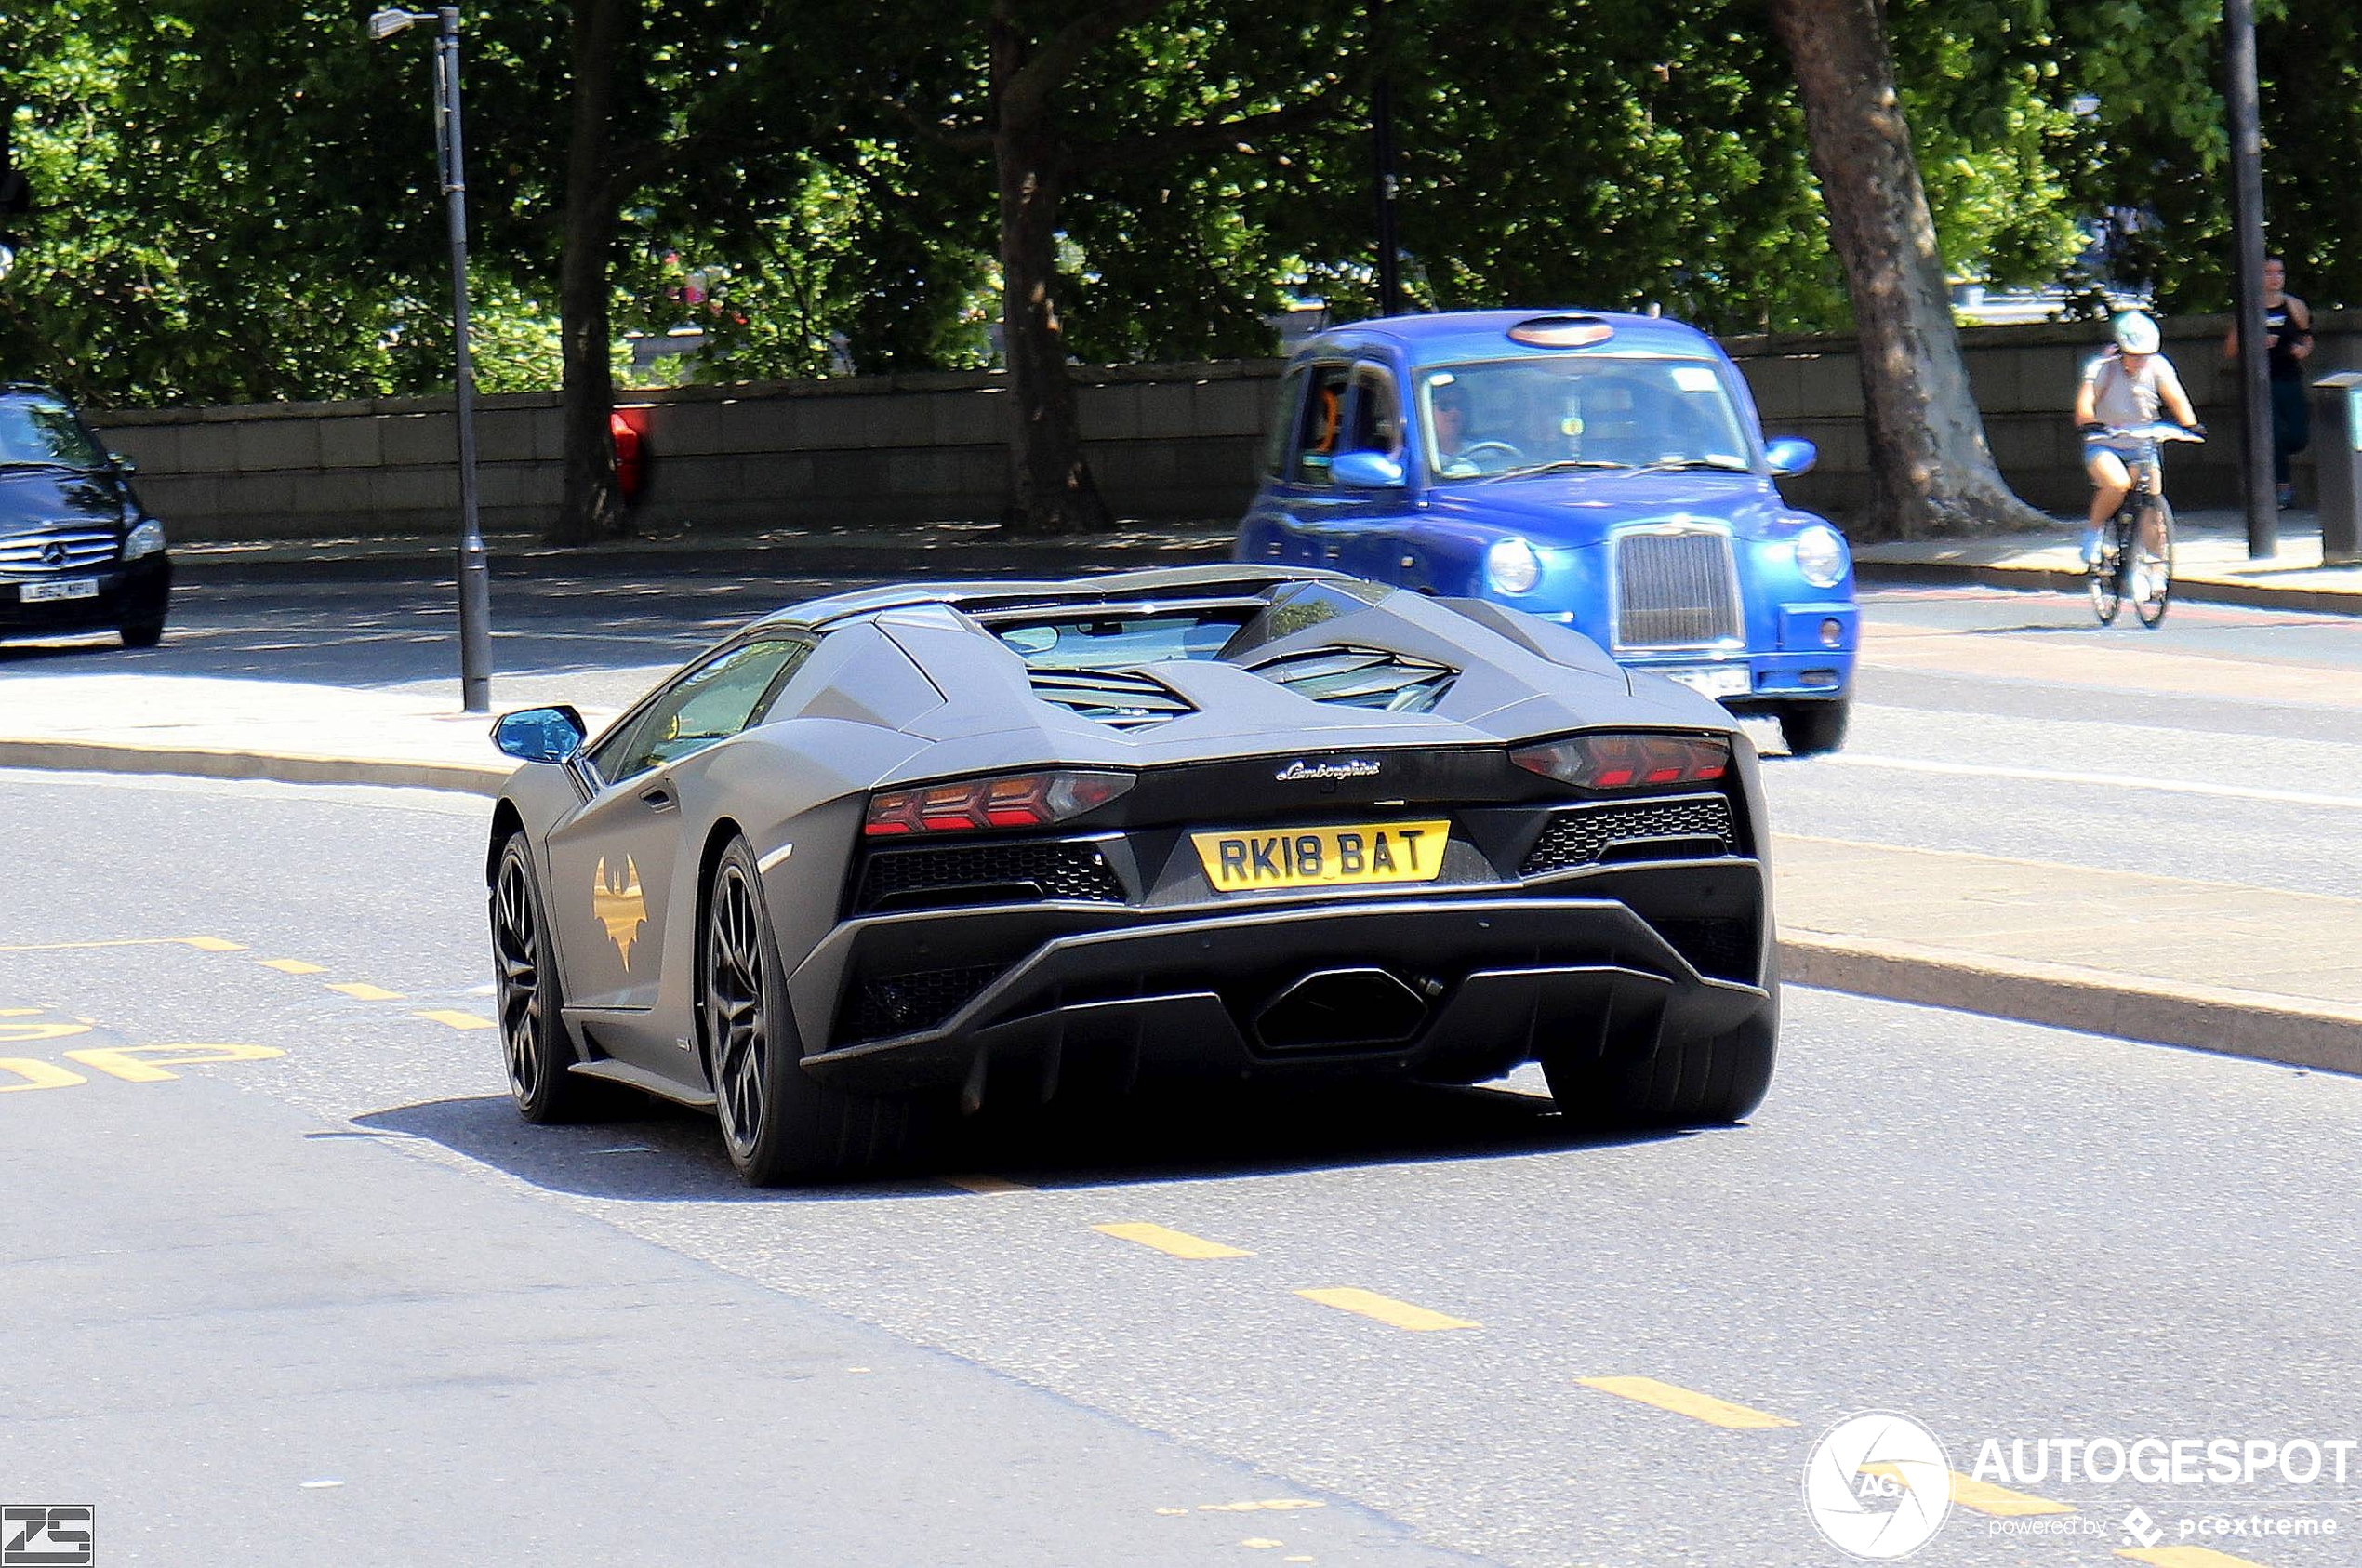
<box><xmin>0</xmin><ymin>382</ymin><xmax>172</xmax><ymax>647</ymax></box>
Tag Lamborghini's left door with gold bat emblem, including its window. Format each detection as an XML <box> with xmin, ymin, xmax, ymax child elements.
<box><xmin>548</xmin><ymin>632</ymin><xmax>810</xmax><ymax>1030</ymax></box>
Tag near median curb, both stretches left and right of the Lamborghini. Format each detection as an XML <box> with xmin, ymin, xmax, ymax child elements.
<box><xmin>0</xmin><ymin>739</ymin><xmax>2362</xmax><ymax>1074</ymax></box>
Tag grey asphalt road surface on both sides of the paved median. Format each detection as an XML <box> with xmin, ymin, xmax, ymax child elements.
<box><xmin>0</xmin><ymin>578</ymin><xmax>2362</xmax><ymax>1568</ymax></box>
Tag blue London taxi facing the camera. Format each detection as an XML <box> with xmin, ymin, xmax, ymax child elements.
<box><xmin>1235</xmin><ymin>310</ymin><xmax>1859</xmax><ymax>756</ymax></box>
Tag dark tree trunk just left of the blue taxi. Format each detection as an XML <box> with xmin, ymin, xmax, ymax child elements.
<box><xmin>992</xmin><ymin>0</ymin><xmax>1110</xmax><ymax>534</ymax></box>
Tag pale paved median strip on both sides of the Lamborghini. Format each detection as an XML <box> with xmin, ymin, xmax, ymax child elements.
<box><xmin>0</xmin><ymin>675</ymin><xmax>2362</xmax><ymax>1072</ymax></box>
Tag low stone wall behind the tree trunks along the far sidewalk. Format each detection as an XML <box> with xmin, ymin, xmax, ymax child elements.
<box><xmin>95</xmin><ymin>314</ymin><xmax>2362</xmax><ymax>538</ymax></box>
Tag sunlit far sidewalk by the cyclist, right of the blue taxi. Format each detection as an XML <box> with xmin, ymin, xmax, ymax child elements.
<box><xmin>1854</xmin><ymin>510</ymin><xmax>2362</xmax><ymax>614</ymax></box>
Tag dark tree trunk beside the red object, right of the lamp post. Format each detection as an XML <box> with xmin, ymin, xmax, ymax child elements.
<box><xmin>551</xmin><ymin>0</ymin><xmax>629</xmax><ymax>546</ymax></box>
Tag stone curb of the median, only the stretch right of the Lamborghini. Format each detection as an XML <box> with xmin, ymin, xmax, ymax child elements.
<box><xmin>1779</xmin><ymin>930</ymin><xmax>2362</xmax><ymax>1074</ymax></box>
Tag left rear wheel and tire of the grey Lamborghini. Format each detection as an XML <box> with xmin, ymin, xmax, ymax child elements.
<box><xmin>697</xmin><ymin>838</ymin><xmax>911</xmax><ymax>1188</ymax></box>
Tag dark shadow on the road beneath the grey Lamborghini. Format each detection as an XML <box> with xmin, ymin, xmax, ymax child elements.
<box><xmin>354</xmin><ymin>1083</ymin><xmax>1689</xmax><ymax>1202</ymax></box>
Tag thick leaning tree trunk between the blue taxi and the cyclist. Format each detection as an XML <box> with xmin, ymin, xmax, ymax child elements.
<box><xmin>1772</xmin><ymin>0</ymin><xmax>2069</xmax><ymax>538</ymax></box>
